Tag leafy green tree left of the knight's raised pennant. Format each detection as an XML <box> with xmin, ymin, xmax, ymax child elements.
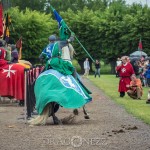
<box><xmin>9</xmin><ymin>8</ymin><xmax>57</xmax><ymax>60</ymax></box>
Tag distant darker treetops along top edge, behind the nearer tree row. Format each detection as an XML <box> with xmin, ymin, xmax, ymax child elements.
<box><xmin>2</xmin><ymin>0</ymin><xmax>110</xmax><ymax>13</ymax></box>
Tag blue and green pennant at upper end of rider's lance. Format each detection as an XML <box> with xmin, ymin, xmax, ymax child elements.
<box><xmin>50</xmin><ymin>6</ymin><xmax>70</xmax><ymax>40</ymax></box>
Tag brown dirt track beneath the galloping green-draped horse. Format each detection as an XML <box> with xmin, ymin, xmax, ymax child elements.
<box><xmin>0</xmin><ymin>79</ymin><xmax>150</xmax><ymax>150</ymax></box>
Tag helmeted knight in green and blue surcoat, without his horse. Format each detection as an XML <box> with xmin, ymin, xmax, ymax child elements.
<box><xmin>39</xmin><ymin>35</ymin><xmax>75</xmax><ymax>75</ymax></box>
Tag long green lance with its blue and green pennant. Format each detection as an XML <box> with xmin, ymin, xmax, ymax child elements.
<box><xmin>50</xmin><ymin>5</ymin><xmax>95</xmax><ymax>62</ymax></box>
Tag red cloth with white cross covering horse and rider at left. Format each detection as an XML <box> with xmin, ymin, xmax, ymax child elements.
<box><xmin>0</xmin><ymin>47</ymin><xmax>24</xmax><ymax>100</ymax></box>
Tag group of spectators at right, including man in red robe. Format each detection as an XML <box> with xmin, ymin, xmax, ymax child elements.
<box><xmin>116</xmin><ymin>56</ymin><xmax>150</xmax><ymax>102</ymax></box>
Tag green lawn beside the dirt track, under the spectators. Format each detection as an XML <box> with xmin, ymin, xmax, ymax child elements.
<box><xmin>89</xmin><ymin>75</ymin><xmax>150</xmax><ymax>125</ymax></box>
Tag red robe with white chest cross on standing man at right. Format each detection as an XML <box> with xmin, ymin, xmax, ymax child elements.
<box><xmin>116</xmin><ymin>63</ymin><xmax>135</xmax><ymax>92</ymax></box>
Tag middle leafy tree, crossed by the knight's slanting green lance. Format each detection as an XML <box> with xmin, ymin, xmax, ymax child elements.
<box><xmin>61</xmin><ymin>7</ymin><xmax>100</xmax><ymax>60</ymax></box>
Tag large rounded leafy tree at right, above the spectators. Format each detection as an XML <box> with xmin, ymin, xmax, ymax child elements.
<box><xmin>95</xmin><ymin>1</ymin><xmax>150</xmax><ymax>62</ymax></box>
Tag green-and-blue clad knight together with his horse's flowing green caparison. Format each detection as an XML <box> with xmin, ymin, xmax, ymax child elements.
<box><xmin>34</xmin><ymin>35</ymin><xmax>92</xmax><ymax>117</ymax></box>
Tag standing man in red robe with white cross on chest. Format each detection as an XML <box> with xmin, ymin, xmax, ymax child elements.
<box><xmin>116</xmin><ymin>56</ymin><xmax>135</xmax><ymax>97</ymax></box>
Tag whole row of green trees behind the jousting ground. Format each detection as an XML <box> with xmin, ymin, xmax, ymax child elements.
<box><xmin>3</xmin><ymin>0</ymin><xmax>150</xmax><ymax>72</ymax></box>
